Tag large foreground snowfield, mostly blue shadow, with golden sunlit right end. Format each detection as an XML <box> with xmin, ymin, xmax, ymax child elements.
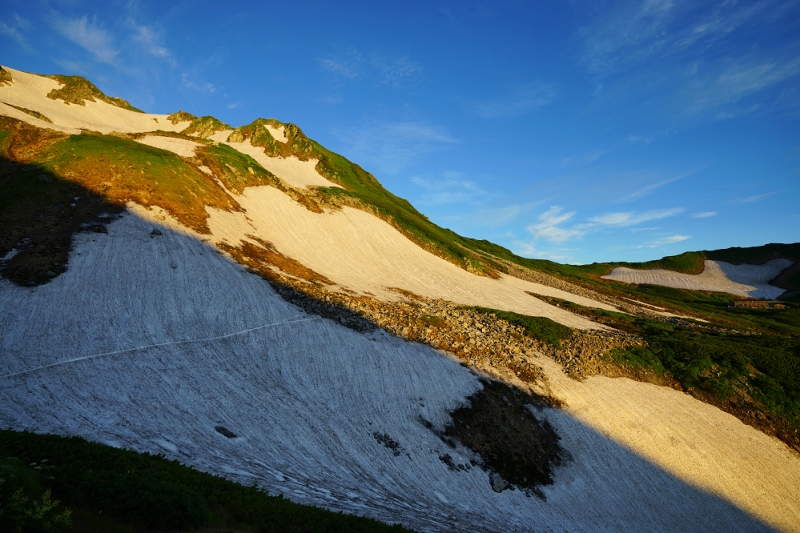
<box><xmin>0</xmin><ymin>213</ymin><xmax>800</xmax><ymax>533</ymax></box>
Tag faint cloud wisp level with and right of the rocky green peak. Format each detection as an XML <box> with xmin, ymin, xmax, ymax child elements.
<box><xmin>333</xmin><ymin>121</ymin><xmax>459</xmax><ymax>174</ymax></box>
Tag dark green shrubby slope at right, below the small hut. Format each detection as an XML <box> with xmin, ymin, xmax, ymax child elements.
<box><xmin>560</xmin><ymin>291</ymin><xmax>800</xmax><ymax>444</ymax></box>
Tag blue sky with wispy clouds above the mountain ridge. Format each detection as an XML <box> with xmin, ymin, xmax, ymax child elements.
<box><xmin>0</xmin><ymin>0</ymin><xmax>800</xmax><ymax>263</ymax></box>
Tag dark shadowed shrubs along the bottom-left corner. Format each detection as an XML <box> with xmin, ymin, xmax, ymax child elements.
<box><xmin>0</xmin><ymin>430</ymin><xmax>409</xmax><ymax>533</ymax></box>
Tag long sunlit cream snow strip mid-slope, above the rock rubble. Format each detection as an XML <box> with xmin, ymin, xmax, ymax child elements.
<box><xmin>205</xmin><ymin>186</ymin><xmax>616</xmax><ymax>329</ymax></box>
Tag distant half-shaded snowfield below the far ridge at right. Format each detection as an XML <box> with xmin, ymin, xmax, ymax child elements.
<box><xmin>602</xmin><ymin>259</ymin><xmax>793</xmax><ymax>300</ymax></box>
